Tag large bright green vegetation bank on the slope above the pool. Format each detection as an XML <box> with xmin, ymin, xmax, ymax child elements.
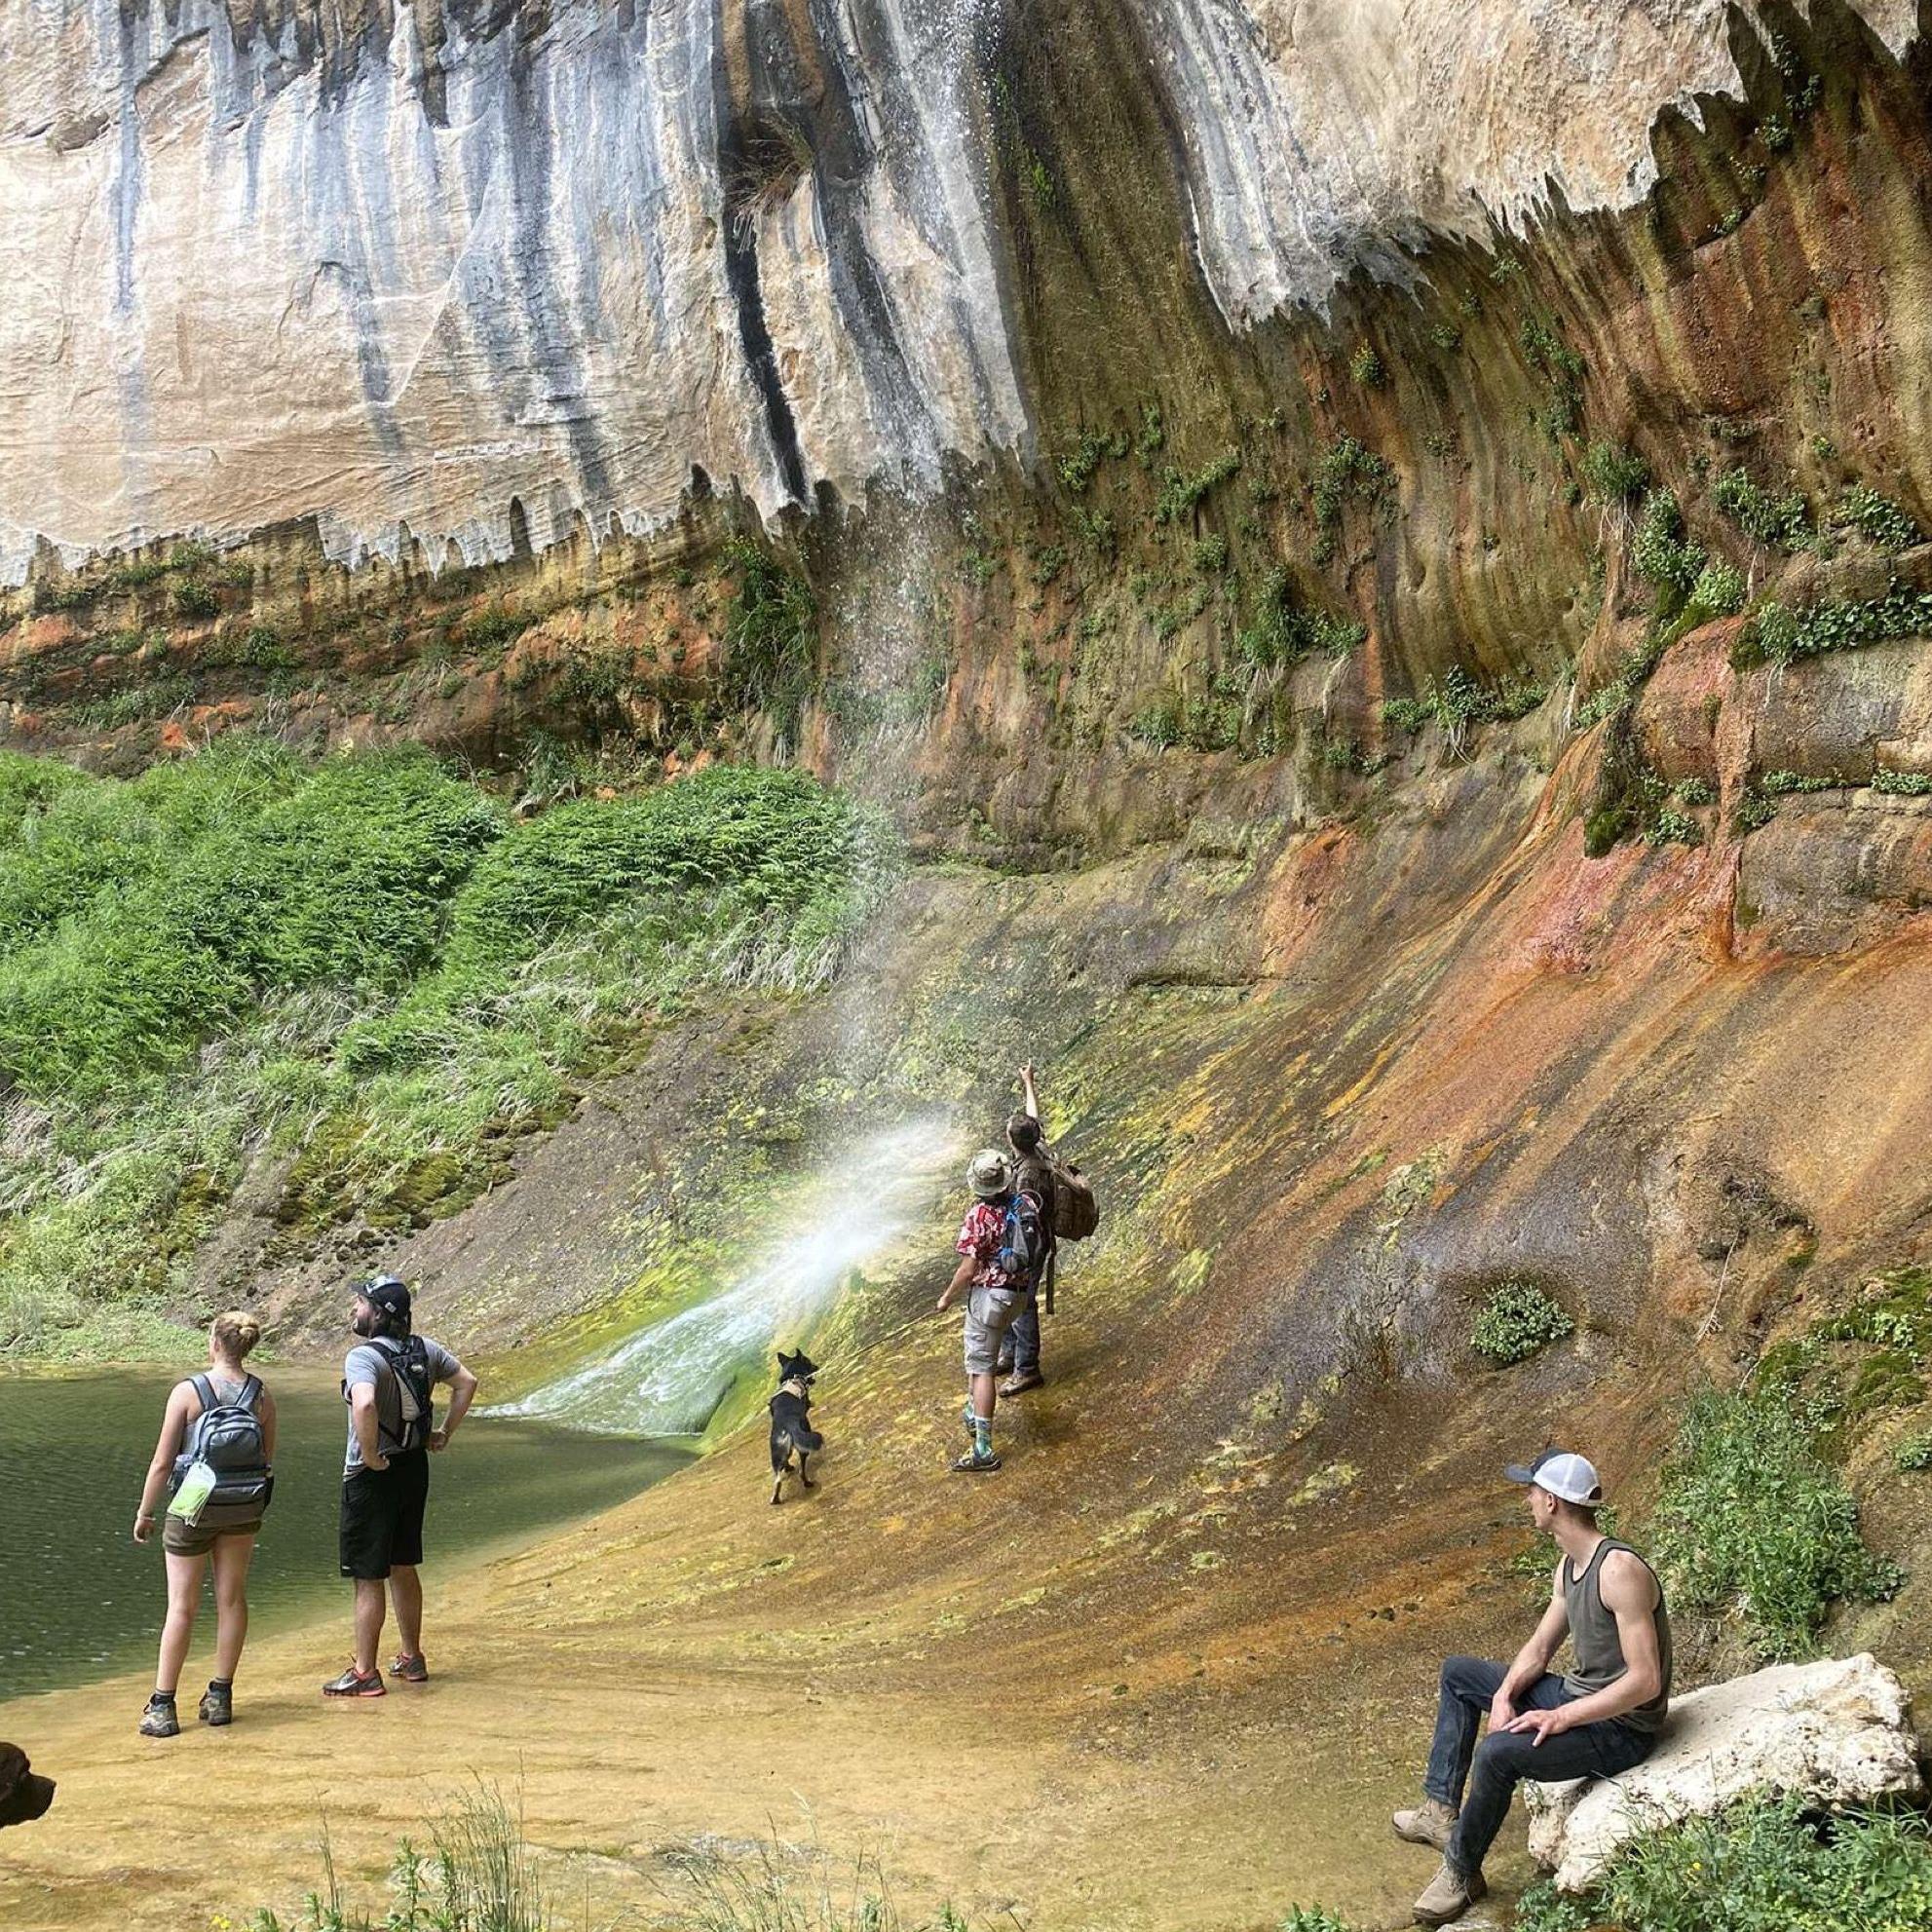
<box><xmin>0</xmin><ymin>739</ymin><xmax>896</xmax><ymax>1352</ymax></box>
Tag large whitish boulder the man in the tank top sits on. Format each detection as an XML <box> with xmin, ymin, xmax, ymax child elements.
<box><xmin>1523</xmin><ymin>1655</ymin><xmax>1924</xmax><ymax>1891</ymax></box>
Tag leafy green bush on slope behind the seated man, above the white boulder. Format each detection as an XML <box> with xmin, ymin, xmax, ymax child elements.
<box><xmin>1651</xmin><ymin>1389</ymin><xmax>1903</xmax><ymax>1657</ymax></box>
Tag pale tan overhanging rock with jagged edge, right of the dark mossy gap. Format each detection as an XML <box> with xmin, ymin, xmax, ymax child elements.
<box><xmin>1134</xmin><ymin>0</ymin><xmax>1913</xmax><ymax>322</ymax></box>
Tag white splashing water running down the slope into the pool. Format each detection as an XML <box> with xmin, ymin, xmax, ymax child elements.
<box><xmin>497</xmin><ymin>1118</ymin><xmax>959</xmax><ymax>1435</ymax></box>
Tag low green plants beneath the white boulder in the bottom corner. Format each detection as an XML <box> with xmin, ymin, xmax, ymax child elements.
<box><xmin>1515</xmin><ymin>1797</ymin><xmax>1932</xmax><ymax>1932</ymax></box>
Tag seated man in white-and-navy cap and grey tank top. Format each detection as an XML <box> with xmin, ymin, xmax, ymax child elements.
<box><xmin>1393</xmin><ymin>1449</ymin><xmax>1671</xmax><ymax>1926</ymax></box>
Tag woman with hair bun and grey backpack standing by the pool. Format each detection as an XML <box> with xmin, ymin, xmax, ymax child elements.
<box><xmin>133</xmin><ymin>1309</ymin><xmax>275</xmax><ymax>1737</ymax></box>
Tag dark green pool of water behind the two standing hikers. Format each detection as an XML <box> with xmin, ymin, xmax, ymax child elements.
<box><xmin>0</xmin><ymin>1370</ymin><xmax>692</xmax><ymax>1698</ymax></box>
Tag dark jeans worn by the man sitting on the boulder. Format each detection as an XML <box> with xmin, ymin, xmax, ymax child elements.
<box><xmin>1421</xmin><ymin>1657</ymin><xmax>1657</xmax><ymax>1875</ymax></box>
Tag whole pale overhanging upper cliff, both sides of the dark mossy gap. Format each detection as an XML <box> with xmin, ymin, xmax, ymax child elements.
<box><xmin>0</xmin><ymin>0</ymin><xmax>1911</xmax><ymax>582</ymax></box>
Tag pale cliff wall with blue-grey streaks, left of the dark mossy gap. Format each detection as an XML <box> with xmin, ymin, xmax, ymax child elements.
<box><xmin>0</xmin><ymin>0</ymin><xmax>1026</xmax><ymax>582</ymax></box>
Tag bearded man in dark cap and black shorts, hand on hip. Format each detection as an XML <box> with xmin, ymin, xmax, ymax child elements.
<box><xmin>322</xmin><ymin>1275</ymin><xmax>477</xmax><ymax>1696</ymax></box>
